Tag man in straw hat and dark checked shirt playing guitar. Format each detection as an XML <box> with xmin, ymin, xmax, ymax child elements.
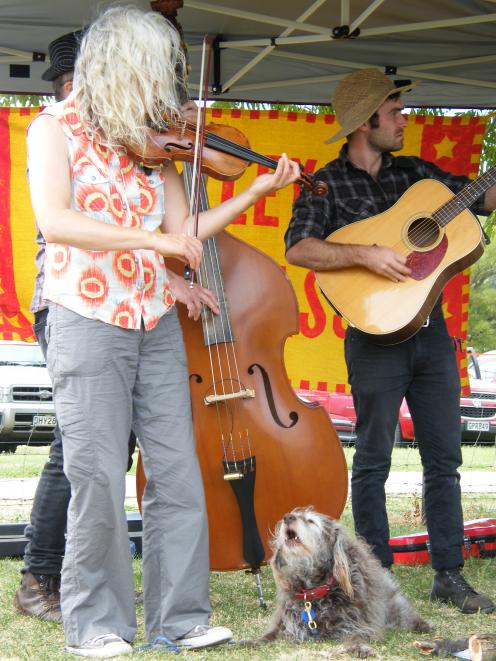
<box><xmin>285</xmin><ymin>69</ymin><xmax>496</xmax><ymax>613</ymax></box>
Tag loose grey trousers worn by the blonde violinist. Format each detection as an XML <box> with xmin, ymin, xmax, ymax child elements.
<box><xmin>48</xmin><ymin>305</ymin><xmax>210</xmax><ymax>645</ymax></box>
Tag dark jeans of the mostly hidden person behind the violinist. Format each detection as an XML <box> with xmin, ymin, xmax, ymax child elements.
<box><xmin>21</xmin><ymin>309</ymin><xmax>136</xmax><ymax>576</ymax></box>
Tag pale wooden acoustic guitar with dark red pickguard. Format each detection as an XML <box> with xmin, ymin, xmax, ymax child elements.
<box><xmin>315</xmin><ymin>166</ymin><xmax>496</xmax><ymax>344</ymax></box>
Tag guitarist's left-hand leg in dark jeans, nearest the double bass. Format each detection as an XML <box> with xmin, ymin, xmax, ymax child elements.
<box><xmin>345</xmin><ymin>329</ymin><xmax>411</xmax><ymax>567</ymax></box>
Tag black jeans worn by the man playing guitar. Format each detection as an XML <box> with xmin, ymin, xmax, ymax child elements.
<box><xmin>345</xmin><ymin>316</ymin><xmax>463</xmax><ymax>570</ymax></box>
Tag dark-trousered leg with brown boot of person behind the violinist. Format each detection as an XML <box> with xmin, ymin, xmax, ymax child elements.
<box><xmin>14</xmin><ymin>309</ymin><xmax>71</xmax><ymax>622</ymax></box>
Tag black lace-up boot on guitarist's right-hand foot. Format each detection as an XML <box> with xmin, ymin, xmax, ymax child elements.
<box><xmin>431</xmin><ymin>569</ymin><xmax>496</xmax><ymax>613</ymax></box>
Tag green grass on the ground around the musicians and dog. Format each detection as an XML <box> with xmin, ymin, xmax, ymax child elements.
<box><xmin>0</xmin><ymin>446</ymin><xmax>496</xmax><ymax>661</ymax></box>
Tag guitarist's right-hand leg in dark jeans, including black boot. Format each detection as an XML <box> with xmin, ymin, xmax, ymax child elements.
<box><xmin>407</xmin><ymin>319</ymin><xmax>495</xmax><ymax>613</ymax></box>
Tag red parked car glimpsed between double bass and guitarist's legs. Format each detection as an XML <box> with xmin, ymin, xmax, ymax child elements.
<box><xmin>296</xmin><ymin>390</ymin><xmax>415</xmax><ymax>445</ymax></box>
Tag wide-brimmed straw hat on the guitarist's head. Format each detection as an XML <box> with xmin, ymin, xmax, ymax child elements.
<box><xmin>325</xmin><ymin>69</ymin><xmax>418</xmax><ymax>144</ymax></box>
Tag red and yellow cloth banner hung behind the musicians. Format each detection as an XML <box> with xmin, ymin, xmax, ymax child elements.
<box><xmin>0</xmin><ymin>108</ymin><xmax>486</xmax><ymax>391</ymax></box>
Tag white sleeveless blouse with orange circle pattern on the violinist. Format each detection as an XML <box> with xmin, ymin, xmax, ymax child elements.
<box><xmin>34</xmin><ymin>94</ymin><xmax>174</xmax><ymax>330</ymax></box>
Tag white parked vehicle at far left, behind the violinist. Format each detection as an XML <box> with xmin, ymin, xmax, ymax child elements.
<box><xmin>0</xmin><ymin>341</ymin><xmax>55</xmax><ymax>452</ymax></box>
